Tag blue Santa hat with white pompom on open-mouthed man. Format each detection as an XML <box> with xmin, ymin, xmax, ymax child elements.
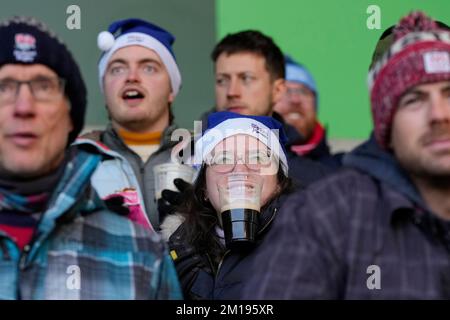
<box><xmin>97</xmin><ymin>18</ymin><xmax>181</xmax><ymax>96</ymax></box>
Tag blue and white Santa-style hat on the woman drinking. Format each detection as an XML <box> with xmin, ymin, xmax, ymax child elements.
<box><xmin>195</xmin><ymin>111</ymin><xmax>289</xmax><ymax>176</ymax></box>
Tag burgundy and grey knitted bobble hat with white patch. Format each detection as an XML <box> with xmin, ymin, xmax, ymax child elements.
<box><xmin>368</xmin><ymin>11</ymin><xmax>450</xmax><ymax>149</ymax></box>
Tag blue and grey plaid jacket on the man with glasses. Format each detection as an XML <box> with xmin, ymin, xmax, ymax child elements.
<box><xmin>0</xmin><ymin>151</ymin><xmax>182</xmax><ymax>299</ymax></box>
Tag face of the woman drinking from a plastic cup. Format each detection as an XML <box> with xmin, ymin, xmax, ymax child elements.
<box><xmin>206</xmin><ymin>134</ymin><xmax>279</xmax><ymax>212</ymax></box>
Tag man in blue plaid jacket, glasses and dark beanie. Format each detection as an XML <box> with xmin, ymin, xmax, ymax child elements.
<box><xmin>0</xmin><ymin>17</ymin><xmax>181</xmax><ymax>299</ymax></box>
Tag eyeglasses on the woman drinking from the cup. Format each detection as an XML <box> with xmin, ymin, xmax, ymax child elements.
<box><xmin>206</xmin><ymin>150</ymin><xmax>275</xmax><ymax>173</ymax></box>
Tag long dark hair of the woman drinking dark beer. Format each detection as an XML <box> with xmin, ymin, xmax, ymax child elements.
<box><xmin>179</xmin><ymin>165</ymin><xmax>293</xmax><ymax>269</ymax></box>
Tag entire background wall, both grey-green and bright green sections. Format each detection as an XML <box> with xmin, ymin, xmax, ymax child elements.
<box><xmin>0</xmin><ymin>0</ymin><xmax>450</xmax><ymax>139</ymax></box>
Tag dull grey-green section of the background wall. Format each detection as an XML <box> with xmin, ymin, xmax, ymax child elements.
<box><xmin>0</xmin><ymin>0</ymin><xmax>216</xmax><ymax>129</ymax></box>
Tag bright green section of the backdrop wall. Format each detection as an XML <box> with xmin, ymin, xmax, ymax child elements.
<box><xmin>216</xmin><ymin>0</ymin><xmax>450</xmax><ymax>138</ymax></box>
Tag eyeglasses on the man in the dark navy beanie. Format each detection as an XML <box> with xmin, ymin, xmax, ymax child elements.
<box><xmin>0</xmin><ymin>77</ymin><xmax>65</xmax><ymax>105</ymax></box>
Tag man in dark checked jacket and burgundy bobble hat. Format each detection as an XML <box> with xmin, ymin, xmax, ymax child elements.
<box><xmin>243</xmin><ymin>12</ymin><xmax>450</xmax><ymax>299</ymax></box>
